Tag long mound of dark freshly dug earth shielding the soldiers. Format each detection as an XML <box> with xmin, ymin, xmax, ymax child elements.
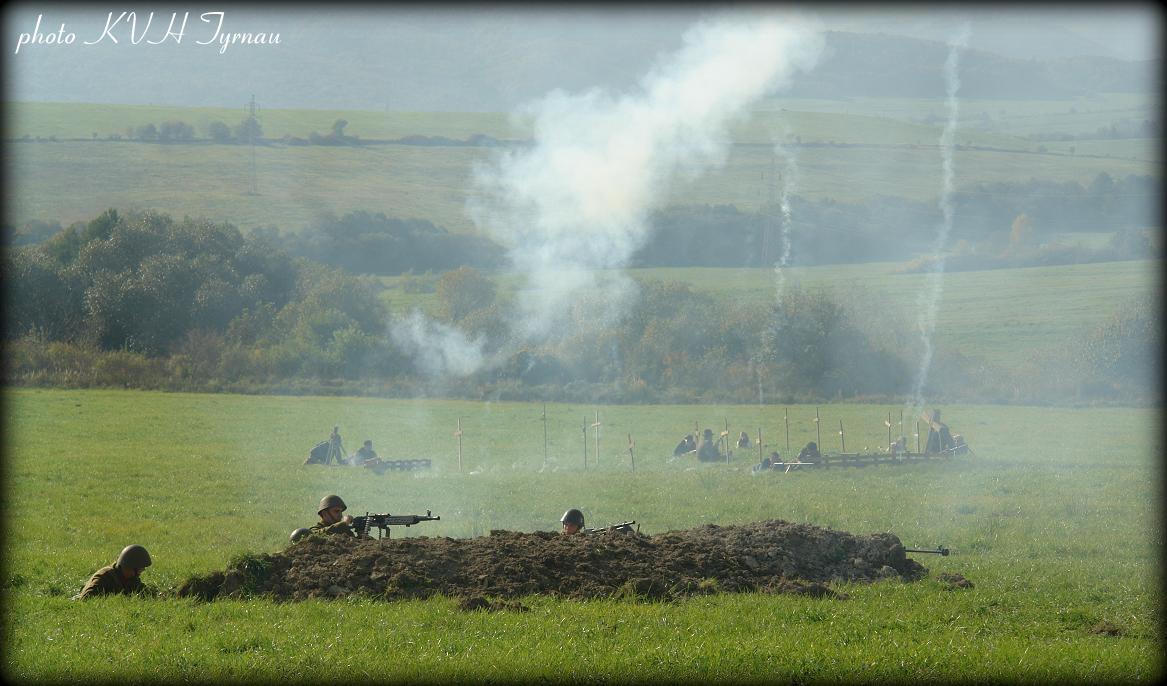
<box><xmin>179</xmin><ymin>519</ymin><xmax>928</xmax><ymax>606</ymax></box>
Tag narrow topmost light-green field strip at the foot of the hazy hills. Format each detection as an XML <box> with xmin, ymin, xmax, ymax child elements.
<box><xmin>5</xmin><ymin>93</ymin><xmax>1158</xmax><ymax>143</ymax></box>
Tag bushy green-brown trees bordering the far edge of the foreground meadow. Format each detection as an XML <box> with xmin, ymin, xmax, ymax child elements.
<box><xmin>5</xmin><ymin>210</ymin><xmax>1160</xmax><ymax>403</ymax></box>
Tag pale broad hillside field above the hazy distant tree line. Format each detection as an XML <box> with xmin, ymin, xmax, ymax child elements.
<box><xmin>4</xmin><ymin>103</ymin><xmax>1159</xmax><ymax>231</ymax></box>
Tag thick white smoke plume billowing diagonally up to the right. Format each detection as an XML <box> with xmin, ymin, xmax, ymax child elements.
<box><xmin>400</xmin><ymin>12</ymin><xmax>822</xmax><ymax>375</ymax></box>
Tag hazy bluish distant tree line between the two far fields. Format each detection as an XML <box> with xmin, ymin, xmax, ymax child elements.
<box><xmin>4</xmin><ymin>172</ymin><xmax>1162</xmax><ymax>275</ymax></box>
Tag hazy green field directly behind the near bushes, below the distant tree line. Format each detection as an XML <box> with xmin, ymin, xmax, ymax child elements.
<box><xmin>382</xmin><ymin>259</ymin><xmax>1160</xmax><ymax>378</ymax></box>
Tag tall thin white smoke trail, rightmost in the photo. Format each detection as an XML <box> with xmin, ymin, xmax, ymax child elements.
<box><xmin>911</xmin><ymin>23</ymin><xmax>969</xmax><ymax>414</ymax></box>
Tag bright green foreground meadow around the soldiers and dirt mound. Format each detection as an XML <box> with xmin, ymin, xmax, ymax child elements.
<box><xmin>2</xmin><ymin>390</ymin><xmax>1163</xmax><ymax>683</ymax></box>
